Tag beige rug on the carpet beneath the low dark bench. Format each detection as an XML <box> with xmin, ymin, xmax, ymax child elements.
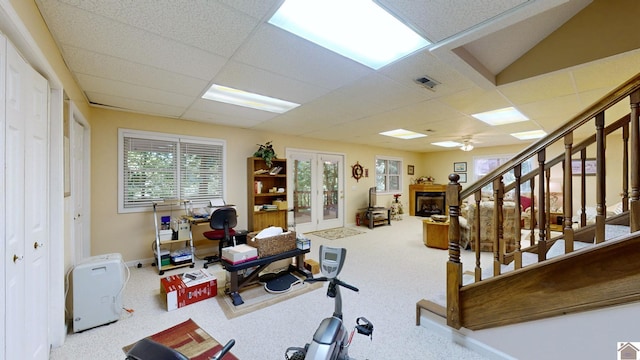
<box><xmin>216</xmin><ymin>274</ymin><xmax>323</xmax><ymax>319</ymax></box>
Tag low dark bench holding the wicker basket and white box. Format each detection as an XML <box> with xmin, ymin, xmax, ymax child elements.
<box><xmin>220</xmin><ymin>249</ymin><xmax>313</xmax><ymax>306</ymax></box>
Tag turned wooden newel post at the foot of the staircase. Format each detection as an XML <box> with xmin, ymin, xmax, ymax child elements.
<box><xmin>446</xmin><ymin>174</ymin><xmax>462</xmax><ymax>329</ymax></box>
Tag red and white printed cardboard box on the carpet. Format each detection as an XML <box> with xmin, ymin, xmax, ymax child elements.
<box><xmin>160</xmin><ymin>269</ymin><xmax>218</xmax><ymax>311</ymax></box>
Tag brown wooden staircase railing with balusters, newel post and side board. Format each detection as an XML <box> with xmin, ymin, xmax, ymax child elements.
<box><xmin>446</xmin><ymin>74</ymin><xmax>640</xmax><ymax>329</ymax></box>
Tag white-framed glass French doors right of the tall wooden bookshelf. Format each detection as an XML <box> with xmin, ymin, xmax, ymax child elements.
<box><xmin>287</xmin><ymin>150</ymin><xmax>344</xmax><ymax>233</ymax></box>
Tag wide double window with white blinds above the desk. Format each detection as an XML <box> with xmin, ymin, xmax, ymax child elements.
<box><xmin>118</xmin><ymin>129</ymin><xmax>225</xmax><ymax>212</ymax></box>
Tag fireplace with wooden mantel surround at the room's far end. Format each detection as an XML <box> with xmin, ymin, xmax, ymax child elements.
<box><xmin>409</xmin><ymin>184</ymin><xmax>449</xmax><ymax>216</ymax></box>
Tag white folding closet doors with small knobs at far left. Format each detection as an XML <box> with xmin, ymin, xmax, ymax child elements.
<box><xmin>0</xmin><ymin>36</ymin><xmax>50</xmax><ymax>359</ymax></box>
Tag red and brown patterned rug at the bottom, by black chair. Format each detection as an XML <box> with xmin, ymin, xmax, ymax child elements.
<box><xmin>122</xmin><ymin>319</ymin><xmax>238</xmax><ymax>360</ymax></box>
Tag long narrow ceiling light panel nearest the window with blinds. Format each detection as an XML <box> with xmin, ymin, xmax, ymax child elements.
<box><xmin>202</xmin><ymin>84</ymin><xmax>300</xmax><ymax>114</ymax></box>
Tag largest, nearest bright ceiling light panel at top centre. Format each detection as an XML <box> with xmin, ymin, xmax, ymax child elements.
<box><xmin>269</xmin><ymin>0</ymin><xmax>430</xmax><ymax>70</ymax></box>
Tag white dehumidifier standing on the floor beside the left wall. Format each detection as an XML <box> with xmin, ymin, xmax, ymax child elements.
<box><xmin>72</xmin><ymin>253</ymin><xmax>126</xmax><ymax>332</ymax></box>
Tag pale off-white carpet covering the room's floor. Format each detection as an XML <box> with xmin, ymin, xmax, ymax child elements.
<box><xmin>49</xmin><ymin>216</ymin><xmax>490</xmax><ymax>360</ymax></box>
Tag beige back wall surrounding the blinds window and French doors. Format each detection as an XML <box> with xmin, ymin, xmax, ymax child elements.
<box><xmin>91</xmin><ymin>108</ymin><xmax>426</xmax><ymax>261</ymax></box>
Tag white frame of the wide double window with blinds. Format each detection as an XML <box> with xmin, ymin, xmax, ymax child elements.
<box><xmin>118</xmin><ymin>128</ymin><xmax>227</xmax><ymax>213</ymax></box>
